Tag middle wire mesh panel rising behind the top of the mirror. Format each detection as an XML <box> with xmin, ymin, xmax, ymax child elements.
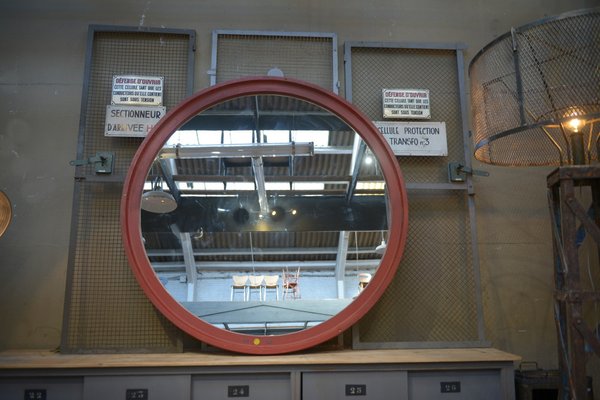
<box><xmin>213</xmin><ymin>31</ymin><xmax>337</xmax><ymax>93</ymax></box>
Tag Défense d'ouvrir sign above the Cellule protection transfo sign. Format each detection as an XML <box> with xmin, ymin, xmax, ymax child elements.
<box><xmin>382</xmin><ymin>89</ymin><xmax>431</xmax><ymax>119</ymax></box>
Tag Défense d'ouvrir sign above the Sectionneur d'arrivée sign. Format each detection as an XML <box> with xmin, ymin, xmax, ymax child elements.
<box><xmin>111</xmin><ymin>75</ymin><xmax>164</xmax><ymax>106</ymax></box>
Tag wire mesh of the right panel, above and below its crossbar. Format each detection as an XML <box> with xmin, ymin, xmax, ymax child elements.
<box><xmin>345</xmin><ymin>43</ymin><xmax>483</xmax><ymax>348</ymax></box>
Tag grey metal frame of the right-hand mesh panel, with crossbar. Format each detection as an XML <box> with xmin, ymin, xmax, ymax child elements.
<box><xmin>344</xmin><ymin>41</ymin><xmax>490</xmax><ymax>349</ymax></box>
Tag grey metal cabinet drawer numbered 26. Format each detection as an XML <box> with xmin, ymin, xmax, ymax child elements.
<box><xmin>408</xmin><ymin>370</ymin><xmax>502</xmax><ymax>400</ymax></box>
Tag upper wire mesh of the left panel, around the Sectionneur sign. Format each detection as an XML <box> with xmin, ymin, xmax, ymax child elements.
<box><xmin>80</xmin><ymin>32</ymin><xmax>190</xmax><ymax>175</ymax></box>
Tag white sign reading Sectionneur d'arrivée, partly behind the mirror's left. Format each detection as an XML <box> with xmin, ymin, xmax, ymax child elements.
<box><xmin>104</xmin><ymin>105</ymin><xmax>167</xmax><ymax>137</ymax></box>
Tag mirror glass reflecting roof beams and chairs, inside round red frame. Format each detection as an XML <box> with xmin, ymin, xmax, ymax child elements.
<box><xmin>141</xmin><ymin>95</ymin><xmax>388</xmax><ymax>335</ymax></box>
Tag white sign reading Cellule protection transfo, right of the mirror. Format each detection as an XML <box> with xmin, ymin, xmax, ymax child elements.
<box><xmin>373</xmin><ymin>121</ymin><xmax>448</xmax><ymax>156</ymax></box>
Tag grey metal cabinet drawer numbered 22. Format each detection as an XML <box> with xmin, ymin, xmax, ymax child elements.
<box><xmin>0</xmin><ymin>377</ymin><xmax>83</xmax><ymax>400</ymax></box>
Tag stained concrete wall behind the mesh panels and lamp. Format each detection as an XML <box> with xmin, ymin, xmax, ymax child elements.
<box><xmin>0</xmin><ymin>0</ymin><xmax>600</xmax><ymax>368</ymax></box>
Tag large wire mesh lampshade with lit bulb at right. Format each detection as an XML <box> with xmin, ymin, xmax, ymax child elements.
<box><xmin>469</xmin><ymin>8</ymin><xmax>600</xmax><ymax>166</ymax></box>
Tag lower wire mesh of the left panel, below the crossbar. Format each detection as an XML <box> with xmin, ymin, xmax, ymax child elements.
<box><xmin>63</xmin><ymin>182</ymin><xmax>177</xmax><ymax>352</ymax></box>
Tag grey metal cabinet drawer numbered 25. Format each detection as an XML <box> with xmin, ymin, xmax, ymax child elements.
<box><xmin>302</xmin><ymin>371</ymin><xmax>406</xmax><ymax>400</ymax></box>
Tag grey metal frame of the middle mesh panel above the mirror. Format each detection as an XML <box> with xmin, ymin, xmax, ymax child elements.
<box><xmin>208</xmin><ymin>29</ymin><xmax>340</xmax><ymax>94</ymax></box>
